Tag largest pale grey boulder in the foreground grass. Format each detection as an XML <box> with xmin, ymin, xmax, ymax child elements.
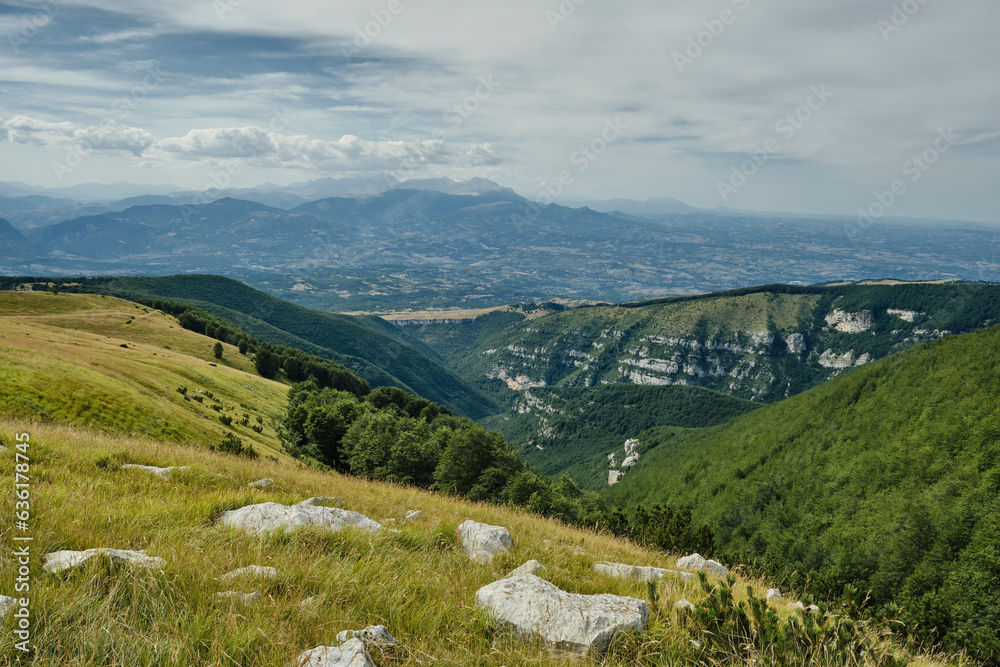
<box><xmin>476</xmin><ymin>574</ymin><xmax>649</xmax><ymax>653</ymax></box>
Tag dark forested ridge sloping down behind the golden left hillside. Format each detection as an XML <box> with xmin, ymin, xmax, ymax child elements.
<box><xmin>4</xmin><ymin>275</ymin><xmax>497</xmax><ymax>418</ymax></box>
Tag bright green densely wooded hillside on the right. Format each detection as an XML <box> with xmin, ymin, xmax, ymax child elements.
<box><xmin>606</xmin><ymin>327</ymin><xmax>1000</xmax><ymax>664</ymax></box>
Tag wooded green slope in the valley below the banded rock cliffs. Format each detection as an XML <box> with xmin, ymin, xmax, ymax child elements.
<box><xmin>484</xmin><ymin>384</ymin><xmax>759</xmax><ymax>491</ymax></box>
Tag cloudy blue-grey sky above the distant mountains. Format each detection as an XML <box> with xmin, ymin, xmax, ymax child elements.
<box><xmin>0</xmin><ymin>0</ymin><xmax>1000</xmax><ymax>222</ymax></box>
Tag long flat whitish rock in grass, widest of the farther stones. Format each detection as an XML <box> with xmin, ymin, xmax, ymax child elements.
<box><xmin>219</xmin><ymin>503</ymin><xmax>382</xmax><ymax>535</ymax></box>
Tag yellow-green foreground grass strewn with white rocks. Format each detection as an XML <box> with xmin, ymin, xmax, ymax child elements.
<box><xmin>0</xmin><ymin>421</ymin><xmax>956</xmax><ymax>667</ymax></box>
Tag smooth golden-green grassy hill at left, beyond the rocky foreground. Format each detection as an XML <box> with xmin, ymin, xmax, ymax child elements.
<box><xmin>0</xmin><ymin>292</ymin><xmax>287</xmax><ymax>456</ymax></box>
